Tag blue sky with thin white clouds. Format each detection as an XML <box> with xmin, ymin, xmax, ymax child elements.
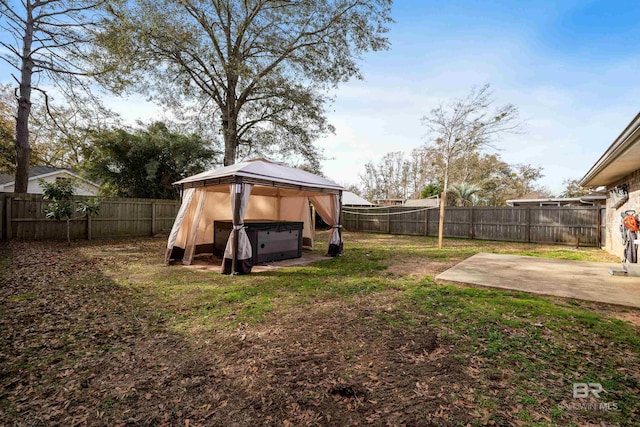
<box><xmin>0</xmin><ymin>0</ymin><xmax>640</xmax><ymax>192</ymax></box>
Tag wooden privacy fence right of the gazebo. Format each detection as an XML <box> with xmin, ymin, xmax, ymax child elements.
<box><xmin>342</xmin><ymin>206</ymin><xmax>604</xmax><ymax>247</ymax></box>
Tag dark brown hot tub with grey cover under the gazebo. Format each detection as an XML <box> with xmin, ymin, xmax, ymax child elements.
<box><xmin>213</xmin><ymin>221</ymin><xmax>304</xmax><ymax>265</ymax></box>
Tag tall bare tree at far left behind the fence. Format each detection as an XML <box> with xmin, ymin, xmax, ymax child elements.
<box><xmin>0</xmin><ymin>0</ymin><xmax>105</xmax><ymax>192</ymax></box>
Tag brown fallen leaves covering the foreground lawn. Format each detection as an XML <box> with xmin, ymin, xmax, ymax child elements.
<box><xmin>0</xmin><ymin>239</ymin><xmax>638</xmax><ymax>427</ymax></box>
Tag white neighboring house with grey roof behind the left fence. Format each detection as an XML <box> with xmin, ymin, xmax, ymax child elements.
<box><xmin>0</xmin><ymin>166</ymin><xmax>100</xmax><ymax>196</ymax></box>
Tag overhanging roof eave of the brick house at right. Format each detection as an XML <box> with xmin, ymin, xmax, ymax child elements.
<box><xmin>580</xmin><ymin>113</ymin><xmax>640</xmax><ymax>187</ymax></box>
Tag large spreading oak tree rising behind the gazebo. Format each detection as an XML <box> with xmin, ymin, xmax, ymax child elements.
<box><xmin>97</xmin><ymin>0</ymin><xmax>391</xmax><ymax>165</ymax></box>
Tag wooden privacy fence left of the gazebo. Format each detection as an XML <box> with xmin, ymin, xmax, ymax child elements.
<box><xmin>0</xmin><ymin>193</ymin><xmax>180</xmax><ymax>240</ymax></box>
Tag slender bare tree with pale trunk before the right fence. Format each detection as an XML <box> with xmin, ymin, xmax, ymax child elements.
<box><xmin>422</xmin><ymin>84</ymin><xmax>522</xmax><ymax>249</ymax></box>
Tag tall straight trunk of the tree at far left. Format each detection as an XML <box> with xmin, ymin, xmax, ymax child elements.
<box><xmin>14</xmin><ymin>2</ymin><xmax>34</xmax><ymax>193</ymax></box>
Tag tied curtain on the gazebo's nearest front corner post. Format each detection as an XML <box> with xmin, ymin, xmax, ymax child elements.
<box><xmin>222</xmin><ymin>184</ymin><xmax>253</xmax><ymax>274</ymax></box>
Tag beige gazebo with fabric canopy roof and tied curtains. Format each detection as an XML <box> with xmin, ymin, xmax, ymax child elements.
<box><xmin>165</xmin><ymin>159</ymin><xmax>343</xmax><ymax>271</ymax></box>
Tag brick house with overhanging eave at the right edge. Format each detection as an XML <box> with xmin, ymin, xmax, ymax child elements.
<box><xmin>580</xmin><ymin>114</ymin><xmax>640</xmax><ymax>257</ymax></box>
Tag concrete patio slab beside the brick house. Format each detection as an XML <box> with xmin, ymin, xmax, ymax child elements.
<box><xmin>436</xmin><ymin>253</ymin><xmax>640</xmax><ymax>308</ymax></box>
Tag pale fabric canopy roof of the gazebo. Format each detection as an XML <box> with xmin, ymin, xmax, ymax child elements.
<box><xmin>173</xmin><ymin>159</ymin><xmax>343</xmax><ymax>194</ymax></box>
